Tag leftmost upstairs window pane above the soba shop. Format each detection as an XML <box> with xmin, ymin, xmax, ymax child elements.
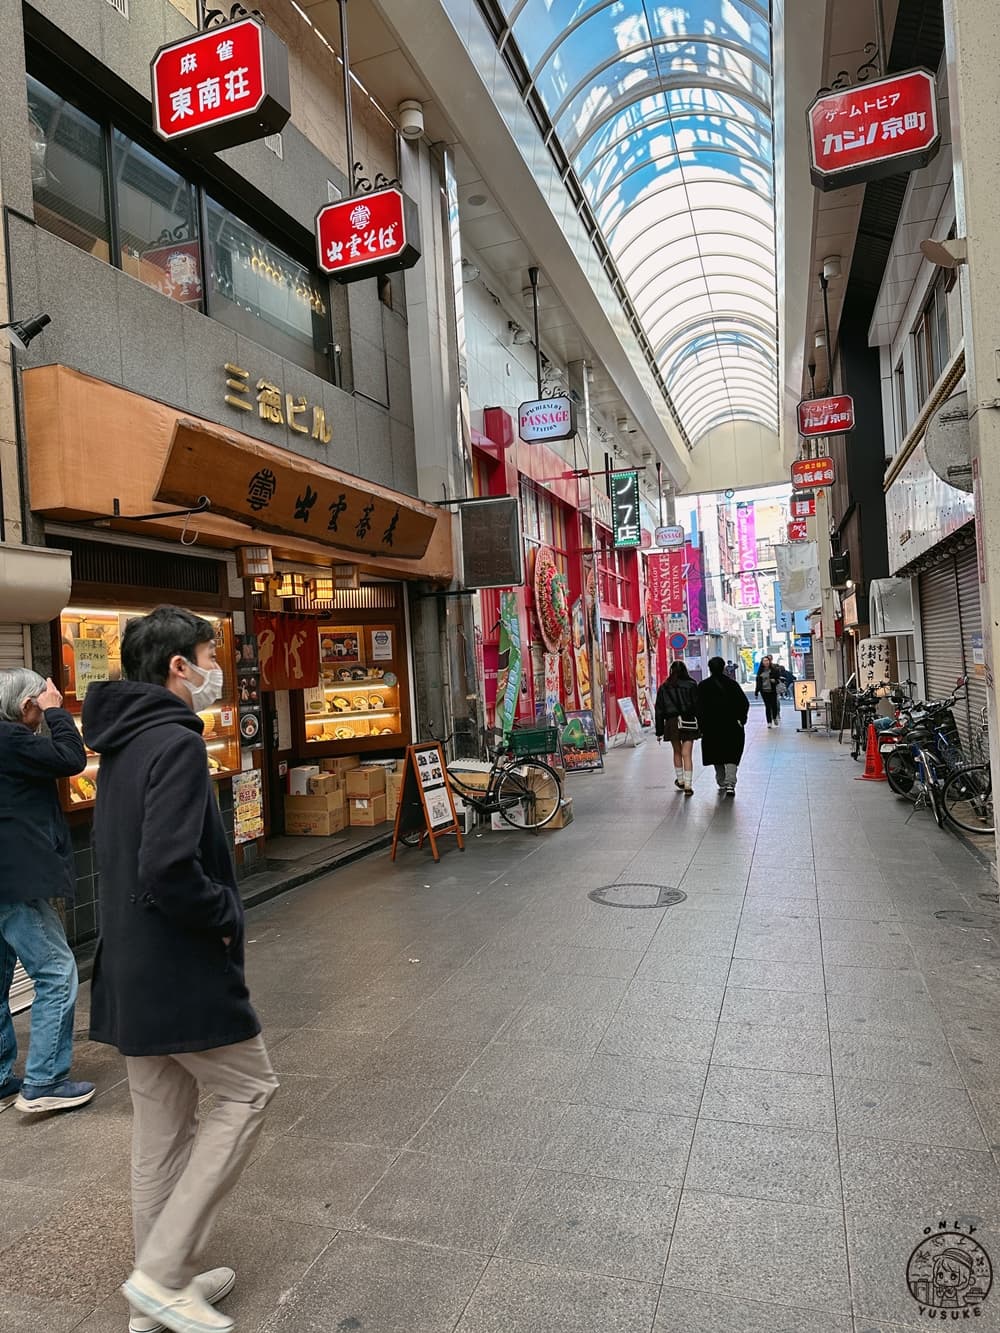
<box><xmin>28</xmin><ymin>76</ymin><xmax>111</xmax><ymax>263</ymax></box>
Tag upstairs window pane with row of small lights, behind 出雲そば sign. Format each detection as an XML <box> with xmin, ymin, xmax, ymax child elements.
<box><xmin>205</xmin><ymin>199</ymin><xmax>331</xmax><ymax>379</ymax></box>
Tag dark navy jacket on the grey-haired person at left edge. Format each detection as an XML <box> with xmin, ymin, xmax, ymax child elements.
<box><xmin>0</xmin><ymin>708</ymin><xmax>87</xmax><ymax>905</ymax></box>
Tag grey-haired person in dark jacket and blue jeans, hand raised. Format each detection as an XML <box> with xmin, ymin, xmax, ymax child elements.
<box><xmin>0</xmin><ymin>668</ymin><xmax>95</xmax><ymax>1114</ymax></box>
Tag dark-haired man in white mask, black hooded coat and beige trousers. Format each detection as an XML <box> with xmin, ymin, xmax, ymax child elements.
<box><xmin>84</xmin><ymin>607</ymin><xmax>277</xmax><ymax>1333</ymax></box>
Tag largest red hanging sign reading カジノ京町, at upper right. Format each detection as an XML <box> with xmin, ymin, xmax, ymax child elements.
<box><xmin>807</xmin><ymin>69</ymin><xmax>941</xmax><ymax>191</ymax></box>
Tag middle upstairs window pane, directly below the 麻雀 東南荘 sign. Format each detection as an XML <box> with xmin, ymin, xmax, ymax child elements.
<box><xmin>113</xmin><ymin>129</ymin><xmax>204</xmax><ymax>309</ymax></box>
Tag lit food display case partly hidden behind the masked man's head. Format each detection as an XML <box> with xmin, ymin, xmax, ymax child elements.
<box><xmin>56</xmin><ymin>607</ymin><xmax>240</xmax><ymax>810</ymax></box>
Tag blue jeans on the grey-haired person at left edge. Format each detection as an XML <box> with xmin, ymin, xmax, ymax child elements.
<box><xmin>0</xmin><ymin>898</ymin><xmax>77</xmax><ymax>1090</ymax></box>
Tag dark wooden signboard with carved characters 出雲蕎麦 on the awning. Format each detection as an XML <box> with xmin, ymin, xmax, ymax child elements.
<box><xmin>155</xmin><ymin>417</ymin><xmax>440</xmax><ymax>560</ymax></box>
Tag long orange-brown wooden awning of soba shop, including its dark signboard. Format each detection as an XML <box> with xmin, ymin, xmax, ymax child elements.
<box><xmin>23</xmin><ymin>365</ymin><xmax>453</xmax><ymax>583</ymax></box>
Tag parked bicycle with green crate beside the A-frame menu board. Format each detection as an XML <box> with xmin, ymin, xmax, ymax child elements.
<box><xmin>400</xmin><ymin>726</ymin><xmax>563</xmax><ymax>846</ymax></box>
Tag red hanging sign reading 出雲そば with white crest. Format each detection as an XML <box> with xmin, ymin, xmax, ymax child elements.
<box><xmin>316</xmin><ymin>185</ymin><xmax>420</xmax><ymax>283</ymax></box>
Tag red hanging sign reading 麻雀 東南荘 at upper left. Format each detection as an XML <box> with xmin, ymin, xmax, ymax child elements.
<box><xmin>149</xmin><ymin>19</ymin><xmax>292</xmax><ymax>152</ymax></box>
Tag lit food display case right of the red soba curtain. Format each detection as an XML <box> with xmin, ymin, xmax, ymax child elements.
<box><xmin>293</xmin><ymin>615</ymin><xmax>409</xmax><ymax>756</ymax></box>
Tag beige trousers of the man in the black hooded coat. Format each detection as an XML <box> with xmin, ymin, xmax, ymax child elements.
<box><xmin>125</xmin><ymin>1037</ymin><xmax>277</xmax><ymax>1289</ymax></box>
